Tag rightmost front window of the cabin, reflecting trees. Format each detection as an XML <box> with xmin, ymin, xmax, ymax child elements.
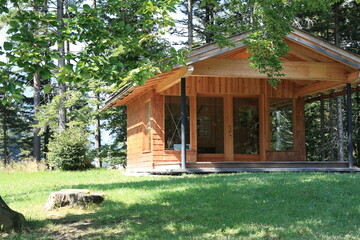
<box><xmin>270</xmin><ymin>98</ymin><xmax>293</xmax><ymax>151</ymax></box>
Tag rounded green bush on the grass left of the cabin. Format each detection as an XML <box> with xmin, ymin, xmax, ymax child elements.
<box><xmin>48</xmin><ymin>128</ymin><xmax>91</xmax><ymax>170</ymax></box>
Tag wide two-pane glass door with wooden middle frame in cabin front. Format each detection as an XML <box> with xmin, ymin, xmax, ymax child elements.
<box><xmin>196</xmin><ymin>96</ymin><xmax>259</xmax><ymax>161</ymax></box>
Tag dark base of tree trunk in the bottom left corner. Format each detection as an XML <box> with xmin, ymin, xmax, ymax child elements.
<box><xmin>0</xmin><ymin>196</ymin><xmax>26</xmax><ymax>232</ymax></box>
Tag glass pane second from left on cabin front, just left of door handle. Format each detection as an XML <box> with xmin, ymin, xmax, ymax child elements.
<box><xmin>196</xmin><ymin>97</ymin><xmax>224</xmax><ymax>153</ymax></box>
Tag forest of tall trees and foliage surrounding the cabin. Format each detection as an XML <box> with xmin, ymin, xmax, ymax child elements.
<box><xmin>0</xmin><ymin>0</ymin><xmax>360</xmax><ymax>169</ymax></box>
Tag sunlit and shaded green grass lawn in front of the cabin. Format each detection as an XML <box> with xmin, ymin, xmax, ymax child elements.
<box><xmin>0</xmin><ymin>170</ymin><xmax>360</xmax><ymax>239</ymax></box>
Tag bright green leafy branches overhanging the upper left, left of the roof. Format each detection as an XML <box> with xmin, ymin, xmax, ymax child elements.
<box><xmin>0</xmin><ymin>0</ymin><xmax>184</xmax><ymax>102</ymax></box>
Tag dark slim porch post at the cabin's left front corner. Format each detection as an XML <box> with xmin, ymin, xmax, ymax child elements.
<box><xmin>181</xmin><ymin>78</ymin><xmax>186</xmax><ymax>169</ymax></box>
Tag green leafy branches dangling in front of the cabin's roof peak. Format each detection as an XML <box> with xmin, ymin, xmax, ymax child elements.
<box><xmin>181</xmin><ymin>0</ymin><xmax>340</xmax><ymax>87</ymax></box>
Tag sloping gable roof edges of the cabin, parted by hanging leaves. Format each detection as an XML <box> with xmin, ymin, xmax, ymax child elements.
<box><xmin>103</xmin><ymin>28</ymin><xmax>360</xmax><ymax>110</ymax></box>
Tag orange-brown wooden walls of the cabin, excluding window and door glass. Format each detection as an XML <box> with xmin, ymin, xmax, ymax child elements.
<box><xmin>127</xmin><ymin>76</ymin><xmax>306</xmax><ymax>169</ymax></box>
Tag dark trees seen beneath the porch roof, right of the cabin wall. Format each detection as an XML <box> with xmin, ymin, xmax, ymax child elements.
<box><xmin>305</xmin><ymin>92</ymin><xmax>360</xmax><ymax>166</ymax></box>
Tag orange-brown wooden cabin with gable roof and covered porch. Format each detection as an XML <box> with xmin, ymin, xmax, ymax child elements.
<box><xmin>104</xmin><ymin>29</ymin><xmax>360</xmax><ymax>172</ymax></box>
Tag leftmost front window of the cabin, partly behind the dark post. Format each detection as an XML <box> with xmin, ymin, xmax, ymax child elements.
<box><xmin>165</xmin><ymin>96</ymin><xmax>190</xmax><ymax>150</ymax></box>
